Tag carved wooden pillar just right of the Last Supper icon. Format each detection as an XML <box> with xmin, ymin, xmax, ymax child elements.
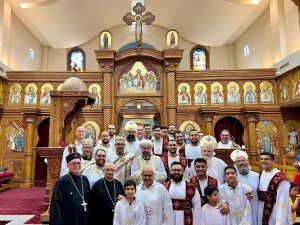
<box><xmin>163</xmin><ymin>49</ymin><xmax>184</xmax><ymax>125</ymax></box>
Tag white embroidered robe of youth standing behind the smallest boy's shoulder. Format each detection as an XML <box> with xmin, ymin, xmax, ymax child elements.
<box><xmin>219</xmin><ymin>183</ymin><xmax>252</xmax><ymax>225</ymax></box>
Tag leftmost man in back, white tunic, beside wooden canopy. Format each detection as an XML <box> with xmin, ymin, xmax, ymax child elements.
<box><xmin>60</xmin><ymin>126</ymin><xmax>85</xmax><ymax>176</ymax></box>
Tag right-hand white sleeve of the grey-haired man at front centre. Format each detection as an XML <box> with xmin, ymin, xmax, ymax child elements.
<box><xmin>160</xmin><ymin>186</ymin><xmax>174</xmax><ymax>225</ymax></box>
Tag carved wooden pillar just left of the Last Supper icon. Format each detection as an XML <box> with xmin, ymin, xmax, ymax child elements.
<box><xmin>95</xmin><ymin>50</ymin><xmax>116</xmax><ymax>129</ymax></box>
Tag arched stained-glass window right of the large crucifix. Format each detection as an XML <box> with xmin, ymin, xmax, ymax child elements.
<box><xmin>191</xmin><ymin>45</ymin><xmax>209</xmax><ymax>70</ymax></box>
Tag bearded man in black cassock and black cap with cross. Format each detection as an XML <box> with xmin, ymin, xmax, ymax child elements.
<box><xmin>50</xmin><ymin>153</ymin><xmax>90</xmax><ymax>225</ymax></box>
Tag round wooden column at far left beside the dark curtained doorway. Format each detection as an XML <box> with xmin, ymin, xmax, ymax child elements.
<box><xmin>20</xmin><ymin>108</ymin><xmax>39</xmax><ymax>188</ymax></box>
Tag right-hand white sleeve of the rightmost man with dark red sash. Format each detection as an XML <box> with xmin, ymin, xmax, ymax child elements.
<box><xmin>272</xmin><ymin>181</ymin><xmax>293</xmax><ymax>225</ymax></box>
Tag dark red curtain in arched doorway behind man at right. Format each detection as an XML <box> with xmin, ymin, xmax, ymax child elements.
<box><xmin>215</xmin><ymin>116</ymin><xmax>244</xmax><ymax>146</ymax></box>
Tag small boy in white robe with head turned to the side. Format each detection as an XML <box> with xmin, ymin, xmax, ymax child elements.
<box><xmin>200</xmin><ymin>186</ymin><xmax>230</xmax><ymax>225</ymax></box>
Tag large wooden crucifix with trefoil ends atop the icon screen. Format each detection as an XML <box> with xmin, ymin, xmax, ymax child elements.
<box><xmin>123</xmin><ymin>2</ymin><xmax>155</xmax><ymax>47</ymax></box>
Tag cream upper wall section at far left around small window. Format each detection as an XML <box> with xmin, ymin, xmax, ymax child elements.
<box><xmin>8</xmin><ymin>13</ymin><xmax>43</xmax><ymax>70</ymax></box>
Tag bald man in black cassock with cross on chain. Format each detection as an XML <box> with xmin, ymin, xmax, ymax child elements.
<box><xmin>90</xmin><ymin>163</ymin><xmax>124</xmax><ymax>225</ymax></box>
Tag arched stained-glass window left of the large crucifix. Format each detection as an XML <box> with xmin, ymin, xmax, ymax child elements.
<box><xmin>67</xmin><ymin>47</ymin><xmax>86</xmax><ymax>71</ymax></box>
